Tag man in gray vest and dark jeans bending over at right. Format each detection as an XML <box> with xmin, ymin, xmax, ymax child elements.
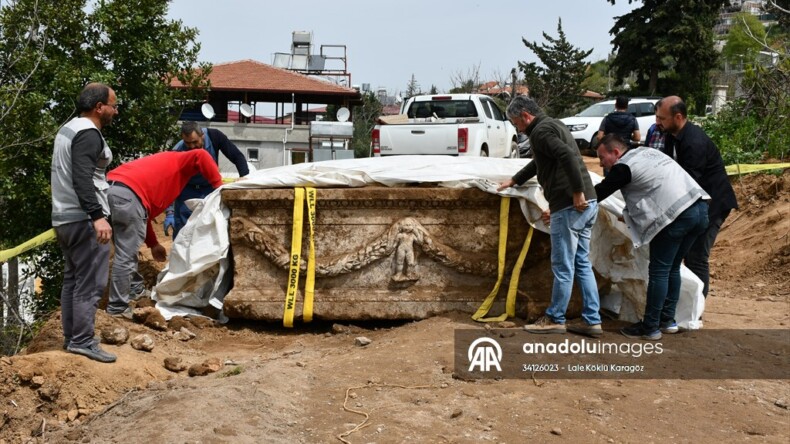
<box><xmin>595</xmin><ymin>134</ymin><xmax>710</xmax><ymax>341</ymax></box>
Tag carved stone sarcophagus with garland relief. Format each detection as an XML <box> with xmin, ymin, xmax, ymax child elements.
<box><xmin>222</xmin><ymin>187</ymin><xmax>578</xmax><ymax>321</ymax></box>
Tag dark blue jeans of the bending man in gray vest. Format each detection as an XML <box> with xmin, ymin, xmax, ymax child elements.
<box><xmin>642</xmin><ymin>200</ymin><xmax>708</xmax><ymax>332</ymax></box>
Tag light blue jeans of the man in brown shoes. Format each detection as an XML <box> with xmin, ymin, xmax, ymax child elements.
<box><xmin>546</xmin><ymin>200</ymin><xmax>601</xmax><ymax>325</ymax></box>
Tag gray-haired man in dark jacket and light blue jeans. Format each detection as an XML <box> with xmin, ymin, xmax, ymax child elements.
<box><xmin>499</xmin><ymin>96</ymin><xmax>602</xmax><ymax>337</ymax></box>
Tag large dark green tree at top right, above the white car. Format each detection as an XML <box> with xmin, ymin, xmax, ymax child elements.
<box><xmin>607</xmin><ymin>0</ymin><xmax>728</xmax><ymax>109</ymax></box>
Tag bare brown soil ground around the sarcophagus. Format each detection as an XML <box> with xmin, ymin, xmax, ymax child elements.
<box><xmin>0</xmin><ymin>167</ymin><xmax>790</xmax><ymax>444</ymax></box>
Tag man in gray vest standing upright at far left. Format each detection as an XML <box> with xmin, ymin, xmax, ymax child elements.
<box><xmin>51</xmin><ymin>83</ymin><xmax>118</xmax><ymax>362</ymax></box>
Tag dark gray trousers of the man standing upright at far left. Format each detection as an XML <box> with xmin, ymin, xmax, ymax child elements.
<box><xmin>55</xmin><ymin>220</ymin><xmax>110</xmax><ymax>347</ymax></box>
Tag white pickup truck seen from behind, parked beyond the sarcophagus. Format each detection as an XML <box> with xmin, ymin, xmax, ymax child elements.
<box><xmin>371</xmin><ymin>94</ymin><xmax>518</xmax><ymax>158</ymax></box>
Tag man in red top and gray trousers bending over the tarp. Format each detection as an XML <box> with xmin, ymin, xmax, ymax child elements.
<box><xmin>107</xmin><ymin>150</ymin><xmax>222</xmax><ymax>319</ymax></box>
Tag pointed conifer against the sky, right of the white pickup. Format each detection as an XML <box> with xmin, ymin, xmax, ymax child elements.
<box><xmin>518</xmin><ymin>19</ymin><xmax>593</xmax><ymax>116</ymax></box>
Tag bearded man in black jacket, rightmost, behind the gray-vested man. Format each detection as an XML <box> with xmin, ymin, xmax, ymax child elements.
<box><xmin>656</xmin><ymin>96</ymin><xmax>738</xmax><ymax>297</ymax></box>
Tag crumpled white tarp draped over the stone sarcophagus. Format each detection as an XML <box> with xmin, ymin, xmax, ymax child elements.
<box><xmin>154</xmin><ymin>156</ymin><xmax>704</xmax><ymax>329</ymax></box>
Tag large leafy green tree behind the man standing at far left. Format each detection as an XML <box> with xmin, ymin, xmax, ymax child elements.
<box><xmin>0</xmin><ymin>0</ymin><xmax>210</xmax><ymax>326</ymax></box>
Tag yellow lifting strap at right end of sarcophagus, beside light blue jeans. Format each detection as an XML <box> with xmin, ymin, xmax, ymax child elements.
<box><xmin>472</xmin><ymin>197</ymin><xmax>533</xmax><ymax>322</ymax></box>
